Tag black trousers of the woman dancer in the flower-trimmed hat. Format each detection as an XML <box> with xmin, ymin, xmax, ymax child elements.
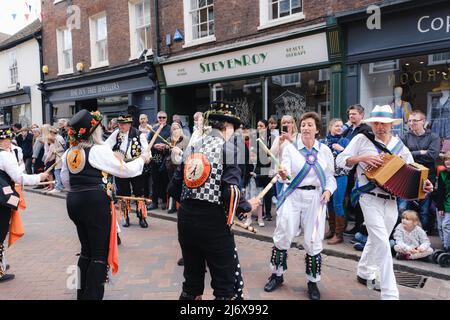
<box><xmin>67</xmin><ymin>190</ymin><xmax>111</xmax><ymax>300</ymax></box>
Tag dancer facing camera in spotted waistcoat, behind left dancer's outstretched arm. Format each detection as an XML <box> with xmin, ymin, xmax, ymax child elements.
<box><xmin>105</xmin><ymin>116</ymin><xmax>148</xmax><ymax>228</ymax></box>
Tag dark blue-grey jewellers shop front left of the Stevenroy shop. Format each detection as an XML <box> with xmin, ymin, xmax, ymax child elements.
<box><xmin>43</xmin><ymin>62</ymin><xmax>157</xmax><ymax>126</ymax></box>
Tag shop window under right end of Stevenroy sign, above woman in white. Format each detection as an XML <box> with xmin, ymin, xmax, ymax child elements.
<box><xmin>267</xmin><ymin>69</ymin><xmax>330</xmax><ymax>133</ymax></box>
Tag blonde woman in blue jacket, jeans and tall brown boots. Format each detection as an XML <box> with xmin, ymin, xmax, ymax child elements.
<box><xmin>322</xmin><ymin>118</ymin><xmax>349</xmax><ymax>244</ymax></box>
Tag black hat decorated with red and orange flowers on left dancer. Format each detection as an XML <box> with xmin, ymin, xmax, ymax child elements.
<box><xmin>67</xmin><ymin>109</ymin><xmax>102</xmax><ymax>146</ymax></box>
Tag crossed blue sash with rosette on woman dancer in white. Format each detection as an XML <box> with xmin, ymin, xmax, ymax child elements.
<box><xmin>276</xmin><ymin>144</ymin><xmax>326</xmax><ymax>210</ymax></box>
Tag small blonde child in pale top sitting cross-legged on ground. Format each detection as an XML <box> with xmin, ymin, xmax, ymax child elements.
<box><xmin>394</xmin><ymin>210</ymin><xmax>433</xmax><ymax>260</ymax></box>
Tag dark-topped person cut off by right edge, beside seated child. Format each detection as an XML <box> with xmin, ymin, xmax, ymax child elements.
<box><xmin>436</xmin><ymin>151</ymin><xmax>450</xmax><ymax>253</ymax></box>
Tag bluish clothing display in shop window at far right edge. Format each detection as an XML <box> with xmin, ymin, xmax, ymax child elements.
<box><xmin>431</xmin><ymin>80</ymin><xmax>450</xmax><ymax>139</ymax></box>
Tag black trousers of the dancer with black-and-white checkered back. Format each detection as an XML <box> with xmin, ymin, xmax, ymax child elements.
<box><xmin>178</xmin><ymin>200</ymin><xmax>237</xmax><ymax>298</ymax></box>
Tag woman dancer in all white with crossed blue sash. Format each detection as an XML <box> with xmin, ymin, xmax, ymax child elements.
<box><xmin>264</xmin><ymin>112</ymin><xmax>336</xmax><ymax>300</ymax></box>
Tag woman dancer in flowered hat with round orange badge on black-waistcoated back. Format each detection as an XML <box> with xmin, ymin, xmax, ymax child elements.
<box><xmin>61</xmin><ymin>109</ymin><xmax>151</xmax><ymax>300</ymax></box>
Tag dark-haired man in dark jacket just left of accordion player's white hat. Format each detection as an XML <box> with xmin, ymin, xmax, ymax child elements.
<box><xmin>342</xmin><ymin>104</ymin><xmax>372</xmax><ymax>236</ymax></box>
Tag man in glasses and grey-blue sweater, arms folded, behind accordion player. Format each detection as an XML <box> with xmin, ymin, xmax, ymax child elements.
<box><xmin>398</xmin><ymin>110</ymin><xmax>440</xmax><ymax>230</ymax></box>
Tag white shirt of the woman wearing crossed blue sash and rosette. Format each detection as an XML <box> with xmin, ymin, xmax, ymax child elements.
<box><xmin>281</xmin><ymin>135</ymin><xmax>336</xmax><ymax>193</ymax></box>
